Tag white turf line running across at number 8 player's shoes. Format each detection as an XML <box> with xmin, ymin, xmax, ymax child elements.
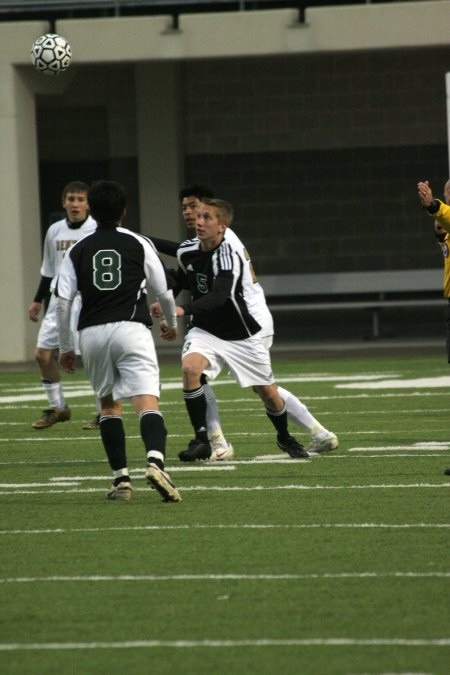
<box><xmin>0</xmin><ymin>482</ymin><xmax>450</xmax><ymax>496</ymax></box>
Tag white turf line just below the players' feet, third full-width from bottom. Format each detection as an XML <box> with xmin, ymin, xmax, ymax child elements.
<box><xmin>0</xmin><ymin>523</ymin><xmax>450</xmax><ymax>536</ymax></box>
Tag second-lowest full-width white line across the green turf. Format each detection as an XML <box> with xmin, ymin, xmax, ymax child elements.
<box><xmin>0</xmin><ymin>572</ymin><xmax>450</xmax><ymax>584</ymax></box>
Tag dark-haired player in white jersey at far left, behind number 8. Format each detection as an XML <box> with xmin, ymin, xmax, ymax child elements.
<box><xmin>28</xmin><ymin>181</ymin><xmax>97</xmax><ymax>429</ymax></box>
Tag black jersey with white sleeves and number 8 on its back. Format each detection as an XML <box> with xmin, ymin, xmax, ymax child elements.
<box><xmin>56</xmin><ymin>225</ymin><xmax>171</xmax><ymax>330</ymax></box>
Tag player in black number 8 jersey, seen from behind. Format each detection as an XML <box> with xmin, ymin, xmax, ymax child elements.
<box><xmin>56</xmin><ymin>181</ymin><xmax>181</xmax><ymax>502</ymax></box>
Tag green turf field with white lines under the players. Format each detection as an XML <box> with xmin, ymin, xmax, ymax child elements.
<box><xmin>0</xmin><ymin>355</ymin><xmax>450</xmax><ymax>675</ymax></box>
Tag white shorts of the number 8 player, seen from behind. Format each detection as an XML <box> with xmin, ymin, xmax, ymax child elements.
<box><xmin>80</xmin><ymin>321</ymin><xmax>160</xmax><ymax>401</ymax></box>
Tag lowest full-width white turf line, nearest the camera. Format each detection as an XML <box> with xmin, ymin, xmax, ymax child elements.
<box><xmin>0</xmin><ymin>637</ymin><xmax>450</xmax><ymax>652</ymax></box>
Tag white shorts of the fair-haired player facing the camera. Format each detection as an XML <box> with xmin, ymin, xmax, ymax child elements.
<box><xmin>182</xmin><ymin>328</ymin><xmax>275</xmax><ymax>387</ymax></box>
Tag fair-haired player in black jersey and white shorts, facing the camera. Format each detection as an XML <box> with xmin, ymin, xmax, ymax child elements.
<box><xmin>159</xmin><ymin>198</ymin><xmax>309</xmax><ymax>461</ymax></box>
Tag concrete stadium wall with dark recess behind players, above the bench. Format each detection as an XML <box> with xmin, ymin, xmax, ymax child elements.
<box><xmin>0</xmin><ymin>1</ymin><xmax>450</xmax><ymax>361</ymax></box>
